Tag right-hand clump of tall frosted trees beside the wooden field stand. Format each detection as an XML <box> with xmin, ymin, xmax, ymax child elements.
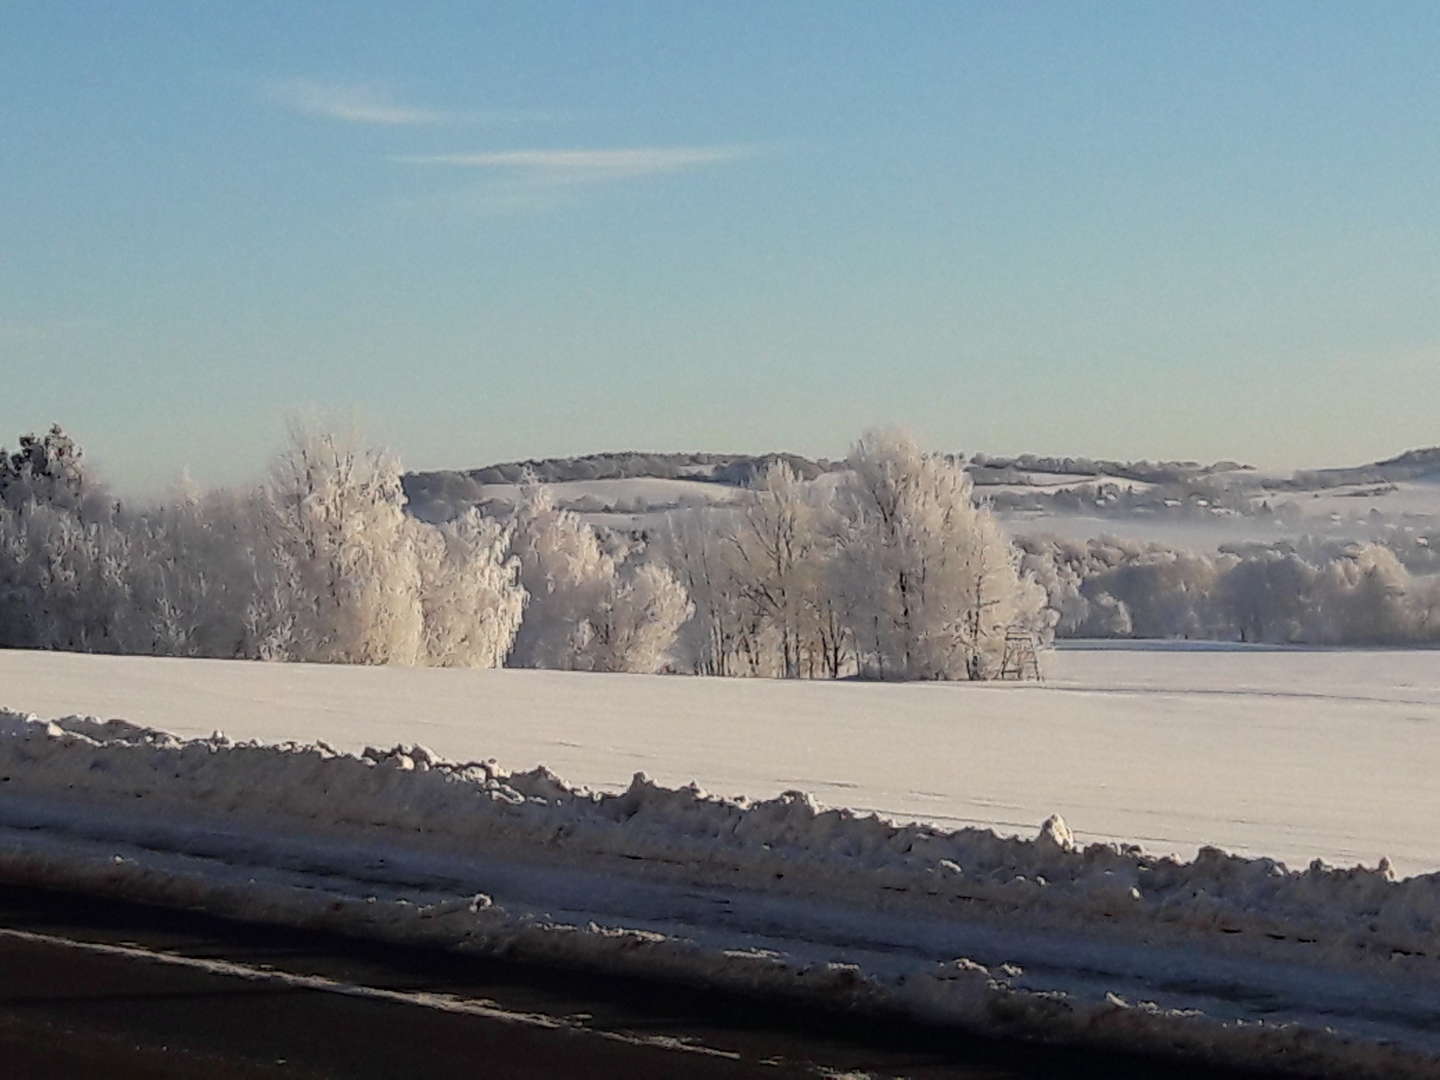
<box><xmin>665</xmin><ymin>432</ymin><xmax>1053</xmax><ymax>680</ymax></box>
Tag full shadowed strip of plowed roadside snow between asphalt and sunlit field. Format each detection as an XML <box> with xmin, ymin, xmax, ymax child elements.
<box><xmin>0</xmin><ymin>713</ymin><xmax>1440</xmax><ymax>1077</ymax></box>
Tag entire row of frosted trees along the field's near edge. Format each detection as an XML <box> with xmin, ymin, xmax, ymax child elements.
<box><xmin>0</xmin><ymin>425</ymin><xmax>1050</xmax><ymax>678</ymax></box>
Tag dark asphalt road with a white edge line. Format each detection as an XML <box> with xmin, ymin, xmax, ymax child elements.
<box><xmin>0</xmin><ymin>887</ymin><xmax>1284</xmax><ymax>1080</ymax></box>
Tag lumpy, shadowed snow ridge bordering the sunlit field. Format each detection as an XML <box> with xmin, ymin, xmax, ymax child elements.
<box><xmin>0</xmin><ymin>711</ymin><xmax>1440</xmax><ymax>966</ymax></box>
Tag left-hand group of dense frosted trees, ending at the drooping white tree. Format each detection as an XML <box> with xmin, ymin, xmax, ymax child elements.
<box><xmin>0</xmin><ymin>426</ymin><xmax>524</xmax><ymax>667</ymax></box>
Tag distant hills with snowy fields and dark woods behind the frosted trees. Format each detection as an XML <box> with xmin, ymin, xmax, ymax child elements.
<box><xmin>405</xmin><ymin>448</ymin><xmax>1440</xmax><ymax>539</ymax></box>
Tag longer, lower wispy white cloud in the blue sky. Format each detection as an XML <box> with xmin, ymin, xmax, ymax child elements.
<box><xmin>390</xmin><ymin>145</ymin><xmax>756</xmax><ymax>184</ymax></box>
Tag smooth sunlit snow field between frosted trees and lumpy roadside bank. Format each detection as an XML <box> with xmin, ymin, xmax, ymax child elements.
<box><xmin>0</xmin><ymin>644</ymin><xmax>1440</xmax><ymax>874</ymax></box>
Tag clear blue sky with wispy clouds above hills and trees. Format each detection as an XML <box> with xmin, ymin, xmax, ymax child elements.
<box><xmin>0</xmin><ymin>0</ymin><xmax>1440</xmax><ymax>491</ymax></box>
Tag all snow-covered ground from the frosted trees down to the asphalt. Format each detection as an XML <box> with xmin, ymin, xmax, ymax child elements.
<box><xmin>0</xmin><ymin>645</ymin><xmax>1440</xmax><ymax>1077</ymax></box>
